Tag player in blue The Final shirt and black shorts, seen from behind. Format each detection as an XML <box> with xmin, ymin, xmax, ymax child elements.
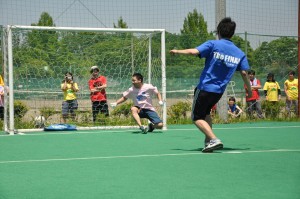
<box><xmin>170</xmin><ymin>17</ymin><xmax>252</xmax><ymax>152</ymax></box>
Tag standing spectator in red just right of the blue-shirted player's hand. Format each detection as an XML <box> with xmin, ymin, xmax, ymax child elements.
<box><xmin>244</xmin><ymin>70</ymin><xmax>263</xmax><ymax>118</ymax></box>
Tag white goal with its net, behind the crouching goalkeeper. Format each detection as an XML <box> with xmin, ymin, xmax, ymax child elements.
<box><xmin>2</xmin><ymin>26</ymin><xmax>166</xmax><ymax>134</ymax></box>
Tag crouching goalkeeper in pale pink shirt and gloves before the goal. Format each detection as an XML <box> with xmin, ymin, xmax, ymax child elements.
<box><xmin>110</xmin><ymin>73</ymin><xmax>164</xmax><ymax>133</ymax></box>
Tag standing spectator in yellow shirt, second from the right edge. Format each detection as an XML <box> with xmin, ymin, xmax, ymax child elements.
<box><xmin>263</xmin><ymin>73</ymin><xmax>281</xmax><ymax>118</ymax></box>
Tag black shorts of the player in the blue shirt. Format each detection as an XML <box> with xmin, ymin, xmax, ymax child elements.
<box><xmin>192</xmin><ymin>88</ymin><xmax>223</xmax><ymax>121</ymax></box>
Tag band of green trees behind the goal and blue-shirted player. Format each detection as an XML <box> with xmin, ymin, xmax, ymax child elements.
<box><xmin>8</xmin><ymin>9</ymin><xmax>298</xmax><ymax>81</ymax></box>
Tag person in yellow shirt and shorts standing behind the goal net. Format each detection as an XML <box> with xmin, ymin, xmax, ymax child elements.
<box><xmin>61</xmin><ymin>72</ymin><xmax>79</xmax><ymax>123</ymax></box>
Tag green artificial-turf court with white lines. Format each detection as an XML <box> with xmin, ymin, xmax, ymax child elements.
<box><xmin>0</xmin><ymin>122</ymin><xmax>300</xmax><ymax>199</ymax></box>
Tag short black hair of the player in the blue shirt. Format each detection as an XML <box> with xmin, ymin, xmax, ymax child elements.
<box><xmin>217</xmin><ymin>17</ymin><xmax>236</xmax><ymax>39</ymax></box>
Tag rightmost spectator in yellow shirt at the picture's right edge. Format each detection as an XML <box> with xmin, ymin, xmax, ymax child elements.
<box><xmin>284</xmin><ymin>71</ymin><xmax>298</xmax><ymax>114</ymax></box>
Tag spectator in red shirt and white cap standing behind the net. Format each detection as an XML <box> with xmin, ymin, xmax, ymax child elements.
<box><xmin>88</xmin><ymin>66</ymin><xmax>109</xmax><ymax>123</ymax></box>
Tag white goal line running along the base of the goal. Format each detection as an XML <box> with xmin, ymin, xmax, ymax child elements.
<box><xmin>0</xmin><ymin>126</ymin><xmax>300</xmax><ymax>137</ymax></box>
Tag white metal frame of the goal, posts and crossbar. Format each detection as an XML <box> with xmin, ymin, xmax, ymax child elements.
<box><xmin>3</xmin><ymin>25</ymin><xmax>167</xmax><ymax>135</ymax></box>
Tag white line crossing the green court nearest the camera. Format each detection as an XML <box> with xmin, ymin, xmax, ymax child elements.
<box><xmin>0</xmin><ymin>149</ymin><xmax>300</xmax><ymax>164</ymax></box>
